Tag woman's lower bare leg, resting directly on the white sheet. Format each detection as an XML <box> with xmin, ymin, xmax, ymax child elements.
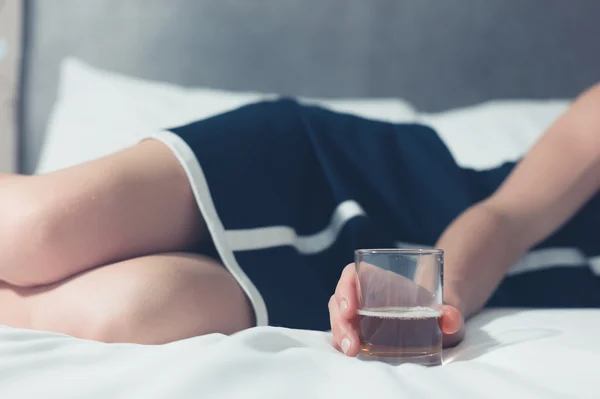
<box><xmin>0</xmin><ymin>253</ymin><xmax>253</xmax><ymax>344</ymax></box>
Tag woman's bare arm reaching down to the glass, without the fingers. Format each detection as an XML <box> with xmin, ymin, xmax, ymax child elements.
<box><xmin>437</xmin><ymin>84</ymin><xmax>600</xmax><ymax>316</ymax></box>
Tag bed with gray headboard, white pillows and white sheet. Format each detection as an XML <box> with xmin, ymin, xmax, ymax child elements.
<box><xmin>0</xmin><ymin>0</ymin><xmax>600</xmax><ymax>399</ymax></box>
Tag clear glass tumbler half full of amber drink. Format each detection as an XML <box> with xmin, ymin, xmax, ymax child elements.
<box><xmin>355</xmin><ymin>249</ymin><xmax>444</xmax><ymax>366</ymax></box>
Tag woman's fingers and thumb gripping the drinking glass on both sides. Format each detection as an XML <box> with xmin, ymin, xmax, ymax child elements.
<box><xmin>329</xmin><ymin>264</ymin><xmax>464</xmax><ymax>356</ymax></box>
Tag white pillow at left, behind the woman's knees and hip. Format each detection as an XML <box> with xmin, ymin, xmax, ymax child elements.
<box><xmin>36</xmin><ymin>58</ymin><xmax>416</xmax><ymax>173</ymax></box>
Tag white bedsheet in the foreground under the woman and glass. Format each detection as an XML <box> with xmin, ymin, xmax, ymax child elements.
<box><xmin>0</xmin><ymin>309</ymin><xmax>600</xmax><ymax>399</ymax></box>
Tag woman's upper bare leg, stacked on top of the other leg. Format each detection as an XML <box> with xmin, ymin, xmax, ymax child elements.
<box><xmin>0</xmin><ymin>140</ymin><xmax>207</xmax><ymax>286</ymax></box>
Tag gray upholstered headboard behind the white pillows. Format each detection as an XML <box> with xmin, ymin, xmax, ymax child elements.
<box><xmin>18</xmin><ymin>0</ymin><xmax>600</xmax><ymax>172</ymax></box>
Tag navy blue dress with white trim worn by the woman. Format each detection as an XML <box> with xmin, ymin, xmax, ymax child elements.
<box><xmin>148</xmin><ymin>99</ymin><xmax>600</xmax><ymax>330</ymax></box>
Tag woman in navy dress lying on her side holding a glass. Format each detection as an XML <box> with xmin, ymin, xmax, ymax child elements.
<box><xmin>0</xmin><ymin>82</ymin><xmax>600</xmax><ymax>355</ymax></box>
